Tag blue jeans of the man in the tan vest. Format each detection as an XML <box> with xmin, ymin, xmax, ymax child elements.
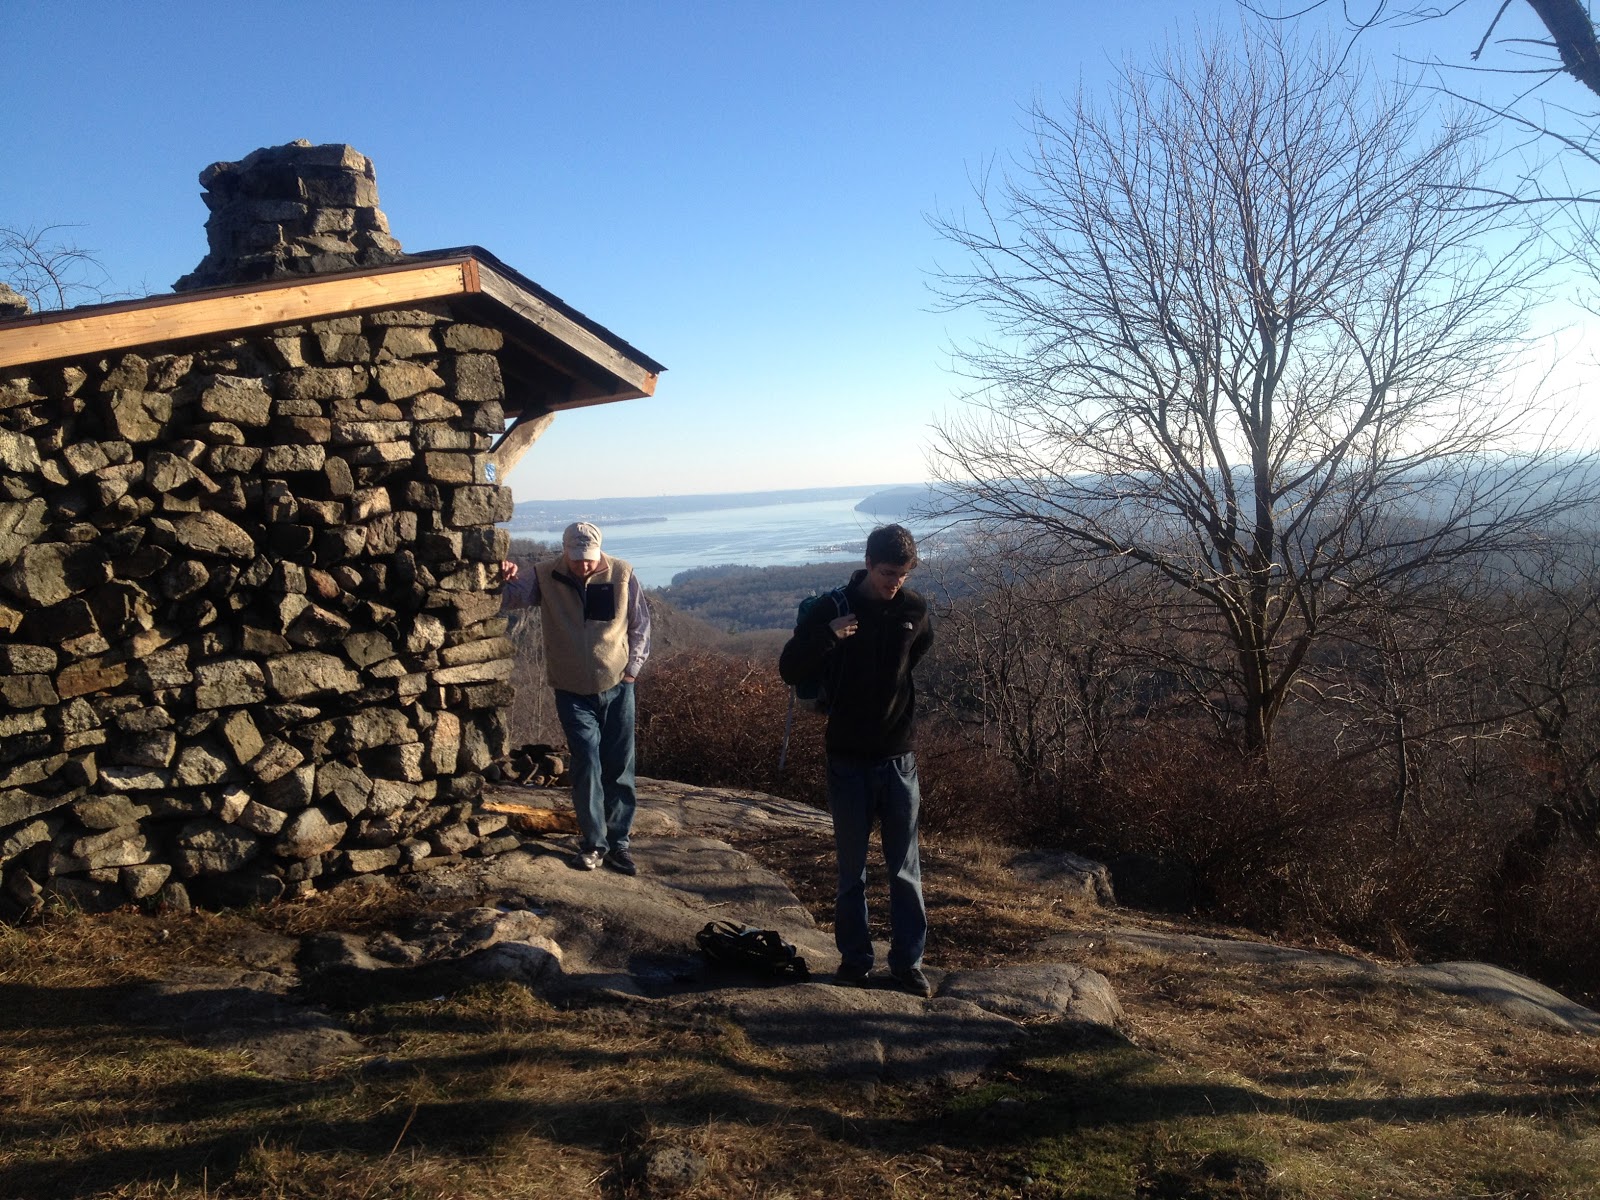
<box><xmin>555</xmin><ymin>683</ymin><xmax>637</xmax><ymax>854</ymax></box>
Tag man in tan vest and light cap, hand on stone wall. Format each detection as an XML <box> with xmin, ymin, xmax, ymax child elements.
<box><xmin>501</xmin><ymin>522</ymin><xmax>650</xmax><ymax>875</ymax></box>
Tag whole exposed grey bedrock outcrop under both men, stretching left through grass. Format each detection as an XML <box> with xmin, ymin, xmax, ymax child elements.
<box><xmin>109</xmin><ymin>781</ymin><xmax>1122</xmax><ymax>1083</ymax></box>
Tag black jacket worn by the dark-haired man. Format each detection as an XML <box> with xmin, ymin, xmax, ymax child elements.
<box><xmin>778</xmin><ymin>571</ymin><xmax>933</xmax><ymax>762</ymax></box>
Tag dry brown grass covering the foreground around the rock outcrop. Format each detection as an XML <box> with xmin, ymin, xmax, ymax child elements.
<box><xmin>0</xmin><ymin>834</ymin><xmax>1600</xmax><ymax>1200</ymax></box>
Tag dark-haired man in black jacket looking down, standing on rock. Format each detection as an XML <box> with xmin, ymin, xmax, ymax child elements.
<box><xmin>778</xmin><ymin>525</ymin><xmax>933</xmax><ymax>995</ymax></box>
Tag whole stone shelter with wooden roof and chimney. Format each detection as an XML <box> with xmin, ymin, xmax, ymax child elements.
<box><xmin>0</xmin><ymin>142</ymin><xmax>662</xmax><ymax>918</ymax></box>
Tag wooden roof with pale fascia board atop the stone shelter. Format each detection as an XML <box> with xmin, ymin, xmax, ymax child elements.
<box><xmin>0</xmin><ymin>246</ymin><xmax>666</xmax><ymax>418</ymax></box>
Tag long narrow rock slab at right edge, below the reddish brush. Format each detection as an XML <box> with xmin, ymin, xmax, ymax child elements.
<box><xmin>1035</xmin><ymin>926</ymin><xmax>1600</xmax><ymax>1035</ymax></box>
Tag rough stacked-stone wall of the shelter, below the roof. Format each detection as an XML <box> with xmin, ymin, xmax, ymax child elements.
<box><xmin>0</xmin><ymin>306</ymin><xmax>512</xmax><ymax>917</ymax></box>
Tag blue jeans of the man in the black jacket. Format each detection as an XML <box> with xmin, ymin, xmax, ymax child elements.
<box><xmin>827</xmin><ymin>754</ymin><xmax>928</xmax><ymax>974</ymax></box>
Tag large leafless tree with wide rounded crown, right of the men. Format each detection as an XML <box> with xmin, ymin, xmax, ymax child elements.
<box><xmin>934</xmin><ymin>27</ymin><xmax>1594</xmax><ymax>752</ymax></box>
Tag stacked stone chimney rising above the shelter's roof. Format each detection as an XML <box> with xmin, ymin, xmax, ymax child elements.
<box><xmin>173</xmin><ymin>139</ymin><xmax>402</xmax><ymax>291</ymax></box>
